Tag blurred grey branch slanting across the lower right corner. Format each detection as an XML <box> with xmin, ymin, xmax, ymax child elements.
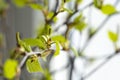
<box><xmin>81</xmin><ymin>53</ymin><xmax>118</xmax><ymax>80</ymax></box>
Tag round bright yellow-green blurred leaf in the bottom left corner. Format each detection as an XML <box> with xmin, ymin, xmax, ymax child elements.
<box><xmin>3</xmin><ymin>59</ymin><xmax>18</xmax><ymax>79</ymax></box>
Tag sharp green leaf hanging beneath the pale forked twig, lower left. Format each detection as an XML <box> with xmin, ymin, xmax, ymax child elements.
<box><xmin>26</xmin><ymin>55</ymin><xmax>43</xmax><ymax>73</ymax></box>
